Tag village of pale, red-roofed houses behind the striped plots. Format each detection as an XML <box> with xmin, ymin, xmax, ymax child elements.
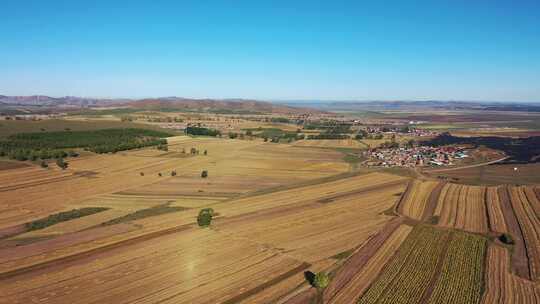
<box><xmin>366</xmin><ymin>146</ymin><xmax>469</xmax><ymax>168</ymax></box>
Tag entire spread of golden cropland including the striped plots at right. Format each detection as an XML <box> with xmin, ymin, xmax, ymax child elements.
<box><xmin>0</xmin><ymin>131</ymin><xmax>540</xmax><ymax>304</ymax></box>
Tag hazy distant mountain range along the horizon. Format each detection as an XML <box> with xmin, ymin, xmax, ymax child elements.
<box><xmin>0</xmin><ymin>95</ymin><xmax>540</xmax><ymax>114</ymax></box>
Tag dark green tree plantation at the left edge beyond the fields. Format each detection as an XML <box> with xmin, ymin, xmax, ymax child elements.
<box><xmin>0</xmin><ymin>128</ymin><xmax>171</xmax><ymax>161</ymax></box>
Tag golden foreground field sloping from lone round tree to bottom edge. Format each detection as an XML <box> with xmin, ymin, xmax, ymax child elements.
<box><xmin>0</xmin><ymin>174</ymin><xmax>406</xmax><ymax>303</ymax></box>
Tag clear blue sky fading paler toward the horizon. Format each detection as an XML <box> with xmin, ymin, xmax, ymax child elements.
<box><xmin>0</xmin><ymin>0</ymin><xmax>540</xmax><ymax>101</ymax></box>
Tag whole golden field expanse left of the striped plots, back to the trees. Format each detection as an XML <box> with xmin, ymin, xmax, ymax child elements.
<box><xmin>0</xmin><ymin>131</ymin><xmax>409</xmax><ymax>303</ymax></box>
